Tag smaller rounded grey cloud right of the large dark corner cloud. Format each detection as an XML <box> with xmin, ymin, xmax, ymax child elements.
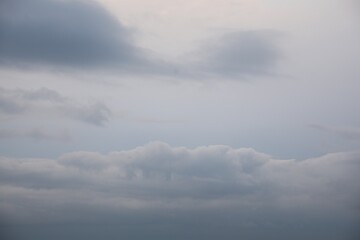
<box><xmin>188</xmin><ymin>31</ymin><xmax>280</xmax><ymax>78</ymax></box>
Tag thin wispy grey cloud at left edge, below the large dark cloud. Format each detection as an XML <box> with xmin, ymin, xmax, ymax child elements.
<box><xmin>0</xmin><ymin>88</ymin><xmax>111</xmax><ymax>125</ymax></box>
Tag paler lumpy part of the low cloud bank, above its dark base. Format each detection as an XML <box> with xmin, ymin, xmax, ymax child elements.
<box><xmin>0</xmin><ymin>142</ymin><xmax>360</xmax><ymax>216</ymax></box>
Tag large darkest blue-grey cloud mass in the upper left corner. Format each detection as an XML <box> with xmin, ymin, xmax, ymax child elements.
<box><xmin>0</xmin><ymin>0</ymin><xmax>156</xmax><ymax>70</ymax></box>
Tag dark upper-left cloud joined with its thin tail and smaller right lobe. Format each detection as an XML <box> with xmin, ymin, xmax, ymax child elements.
<box><xmin>0</xmin><ymin>0</ymin><xmax>279</xmax><ymax>78</ymax></box>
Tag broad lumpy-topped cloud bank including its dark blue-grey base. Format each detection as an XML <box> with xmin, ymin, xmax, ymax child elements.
<box><xmin>0</xmin><ymin>142</ymin><xmax>360</xmax><ymax>239</ymax></box>
